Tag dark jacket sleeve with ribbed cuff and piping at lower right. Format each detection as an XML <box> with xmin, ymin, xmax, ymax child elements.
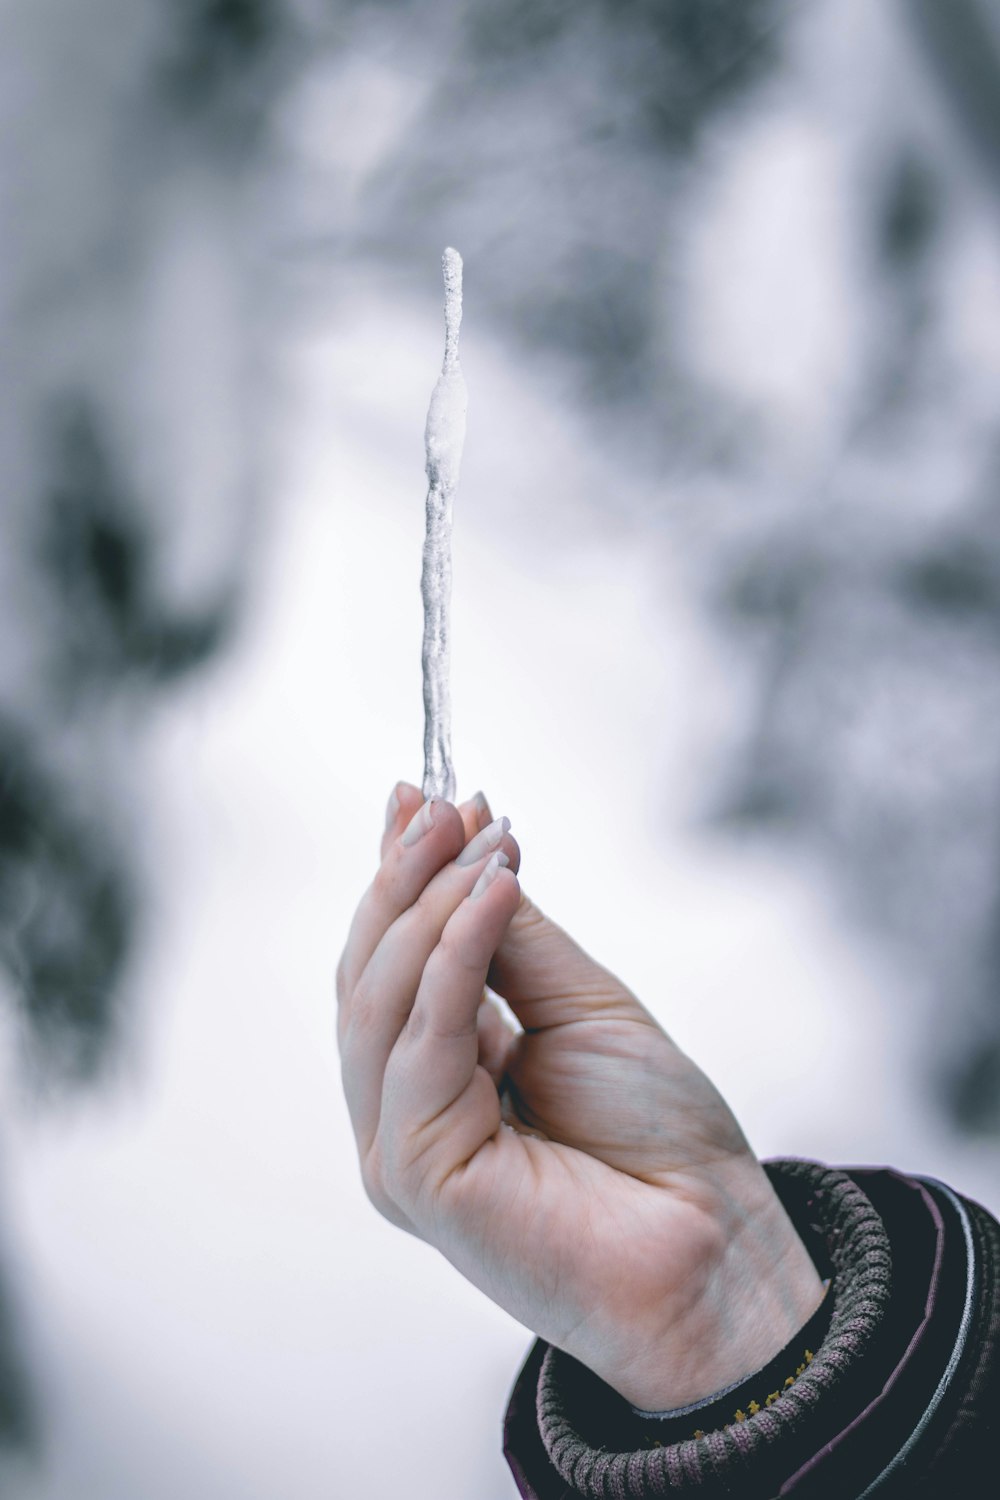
<box><xmin>504</xmin><ymin>1161</ymin><xmax>1000</xmax><ymax>1500</ymax></box>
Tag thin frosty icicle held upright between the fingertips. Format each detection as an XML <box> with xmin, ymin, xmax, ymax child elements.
<box><xmin>420</xmin><ymin>249</ymin><xmax>468</xmax><ymax>801</ymax></box>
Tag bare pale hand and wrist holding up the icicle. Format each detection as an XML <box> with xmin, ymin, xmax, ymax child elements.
<box><xmin>337</xmin><ymin>782</ymin><xmax>823</xmax><ymax>1410</ymax></box>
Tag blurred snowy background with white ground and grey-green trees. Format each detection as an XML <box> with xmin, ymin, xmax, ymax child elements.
<box><xmin>0</xmin><ymin>0</ymin><xmax>1000</xmax><ymax>1500</ymax></box>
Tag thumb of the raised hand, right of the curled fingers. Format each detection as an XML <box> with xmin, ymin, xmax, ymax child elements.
<box><xmin>487</xmin><ymin>893</ymin><xmax>632</xmax><ymax>1031</ymax></box>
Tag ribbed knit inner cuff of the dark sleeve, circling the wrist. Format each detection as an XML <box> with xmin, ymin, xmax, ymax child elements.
<box><xmin>525</xmin><ymin>1161</ymin><xmax>892</xmax><ymax>1500</ymax></box>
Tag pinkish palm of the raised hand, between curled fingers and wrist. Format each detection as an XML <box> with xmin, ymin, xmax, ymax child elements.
<box><xmin>434</xmin><ymin>930</ymin><xmax>753</xmax><ymax>1361</ymax></box>
